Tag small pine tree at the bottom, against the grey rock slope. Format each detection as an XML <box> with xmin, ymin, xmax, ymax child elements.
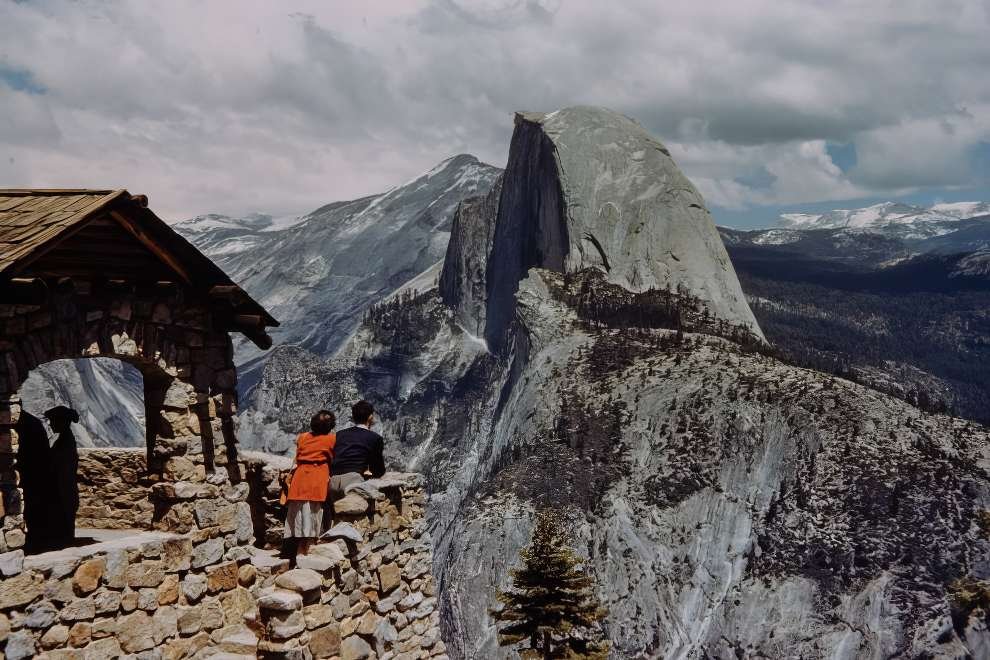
<box><xmin>491</xmin><ymin>509</ymin><xmax>608</xmax><ymax>660</ymax></box>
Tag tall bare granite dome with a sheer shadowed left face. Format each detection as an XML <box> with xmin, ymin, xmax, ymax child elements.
<box><xmin>485</xmin><ymin>107</ymin><xmax>762</xmax><ymax>349</ymax></box>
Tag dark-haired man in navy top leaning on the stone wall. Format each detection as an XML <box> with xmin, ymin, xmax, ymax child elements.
<box><xmin>330</xmin><ymin>401</ymin><xmax>385</xmax><ymax>500</ymax></box>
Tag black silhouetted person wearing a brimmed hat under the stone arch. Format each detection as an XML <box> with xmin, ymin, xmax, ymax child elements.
<box><xmin>45</xmin><ymin>406</ymin><xmax>79</xmax><ymax>548</ymax></box>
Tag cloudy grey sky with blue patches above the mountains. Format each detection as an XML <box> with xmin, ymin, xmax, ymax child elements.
<box><xmin>0</xmin><ymin>0</ymin><xmax>990</xmax><ymax>227</ymax></box>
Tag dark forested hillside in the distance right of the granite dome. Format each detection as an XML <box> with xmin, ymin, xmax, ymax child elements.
<box><xmin>729</xmin><ymin>245</ymin><xmax>990</xmax><ymax>423</ymax></box>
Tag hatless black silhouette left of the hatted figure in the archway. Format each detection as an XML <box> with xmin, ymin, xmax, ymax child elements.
<box><xmin>16</xmin><ymin>411</ymin><xmax>55</xmax><ymax>554</ymax></box>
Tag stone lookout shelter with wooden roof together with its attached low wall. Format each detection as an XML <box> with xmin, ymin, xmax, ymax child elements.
<box><xmin>0</xmin><ymin>190</ymin><xmax>446</xmax><ymax>660</ymax></box>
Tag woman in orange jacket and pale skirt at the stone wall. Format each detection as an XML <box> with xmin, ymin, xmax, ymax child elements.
<box><xmin>285</xmin><ymin>410</ymin><xmax>337</xmax><ymax>555</ymax></box>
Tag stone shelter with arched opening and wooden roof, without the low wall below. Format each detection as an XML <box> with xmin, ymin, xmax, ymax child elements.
<box><xmin>0</xmin><ymin>190</ymin><xmax>278</xmax><ymax>550</ymax></box>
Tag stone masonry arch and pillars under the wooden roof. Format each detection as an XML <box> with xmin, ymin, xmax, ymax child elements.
<box><xmin>0</xmin><ymin>282</ymin><xmax>237</xmax><ymax>550</ymax></box>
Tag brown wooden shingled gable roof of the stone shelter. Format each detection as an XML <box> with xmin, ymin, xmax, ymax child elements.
<box><xmin>0</xmin><ymin>189</ymin><xmax>278</xmax><ymax>340</ymax></box>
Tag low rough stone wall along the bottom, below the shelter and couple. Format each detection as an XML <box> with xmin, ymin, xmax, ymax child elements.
<box><xmin>0</xmin><ymin>466</ymin><xmax>446</xmax><ymax>660</ymax></box>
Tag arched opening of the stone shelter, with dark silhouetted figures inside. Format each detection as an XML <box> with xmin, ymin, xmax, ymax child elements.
<box><xmin>15</xmin><ymin>357</ymin><xmax>172</xmax><ymax>554</ymax></box>
